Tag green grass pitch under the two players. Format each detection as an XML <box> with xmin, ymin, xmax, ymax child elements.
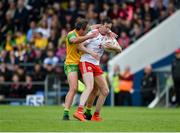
<box><xmin>0</xmin><ymin>106</ymin><xmax>180</xmax><ymax>132</ymax></box>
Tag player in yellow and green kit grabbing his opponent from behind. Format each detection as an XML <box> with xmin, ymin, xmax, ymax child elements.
<box><xmin>63</xmin><ymin>19</ymin><xmax>99</xmax><ymax>120</ymax></box>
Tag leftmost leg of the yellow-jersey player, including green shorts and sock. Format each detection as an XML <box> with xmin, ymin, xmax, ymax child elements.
<box><xmin>63</xmin><ymin>66</ymin><xmax>78</xmax><ymax>120</ymax></box>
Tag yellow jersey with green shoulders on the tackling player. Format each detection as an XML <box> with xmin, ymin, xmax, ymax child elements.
<box><xmin>65</xmin><ymin>30</ymin><xmax>81</xmax><ymax>65</ymax></box>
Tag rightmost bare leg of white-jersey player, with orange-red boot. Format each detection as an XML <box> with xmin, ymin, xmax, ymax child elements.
<box><xmin>91</xmin><ymin>75</ymin><xmax>109</xmax><ymax>121</ymax></box>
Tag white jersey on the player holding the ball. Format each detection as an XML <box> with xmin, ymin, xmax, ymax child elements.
<box><xmin>80</xmin><ymin>30</ymin><xmax>109</xmax><ymax>65</ymax></box>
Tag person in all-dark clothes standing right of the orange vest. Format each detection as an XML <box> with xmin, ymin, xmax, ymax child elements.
<box><xmin>141</xmin><ymin>65</ymin><xmax>157</xmax><ymax>106</ymax></box>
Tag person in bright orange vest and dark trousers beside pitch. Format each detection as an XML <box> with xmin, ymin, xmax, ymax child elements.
<box><xmin>119</xmin><ymin>66</ymin><xmax>134</xmax><ymax>106</ymax></box>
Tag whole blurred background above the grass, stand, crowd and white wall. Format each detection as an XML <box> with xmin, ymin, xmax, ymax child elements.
<box><xmin>0</xmin><ymin>0</ymin><xmax>180</xmax><ymax>108</ymax></box>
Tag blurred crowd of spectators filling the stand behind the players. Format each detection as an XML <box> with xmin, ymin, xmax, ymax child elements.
<box><xmin>0</xmin><ymin>0</ymin><xmax>176</xmax><ymax>102</ymax></box>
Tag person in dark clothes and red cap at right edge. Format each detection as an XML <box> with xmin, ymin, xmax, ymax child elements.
<box><xmin>172</xmin><ymin>49</ymin><xmax>180</xmax><ymax>106</ymax></box>
